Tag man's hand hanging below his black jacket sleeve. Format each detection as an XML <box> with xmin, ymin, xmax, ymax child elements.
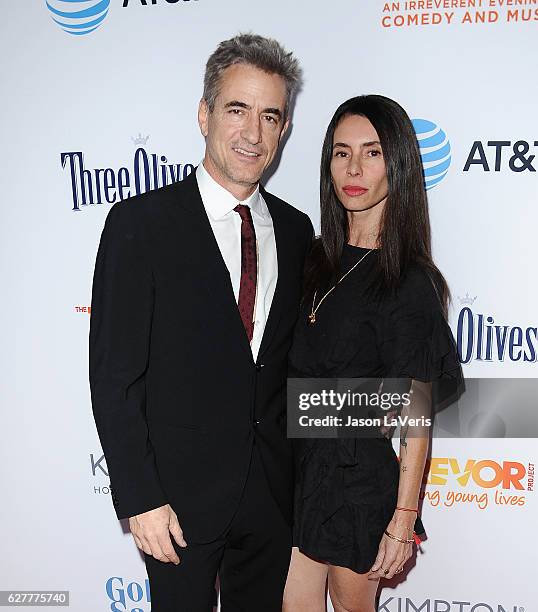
<box><xmin>129</xmin><ymin>504</ymin><xmax>187</xmax><ymax>565</ymax></box>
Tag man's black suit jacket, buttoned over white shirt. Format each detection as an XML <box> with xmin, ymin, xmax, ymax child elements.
<box><xmin>89</xmin><ymin>173</ymin><xmax>313</xmax><ymax>542</ymax></box>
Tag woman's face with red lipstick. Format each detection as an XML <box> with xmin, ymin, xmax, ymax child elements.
<box><xmin>331</xmin><ymin>115</ymin><xmax>388</xmax><ymax>211</ymax></box>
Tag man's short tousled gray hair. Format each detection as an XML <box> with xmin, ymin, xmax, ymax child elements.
<box><xmin>204</xmin><ymin>34</ymin><xmax>302</xmax><ymax>118</ymax></box>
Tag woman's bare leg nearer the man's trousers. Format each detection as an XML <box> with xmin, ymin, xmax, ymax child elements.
<box><xmin>282</xmin><ymin>546</ymin><xmax>328</xmax><ymax>612</ymax></box>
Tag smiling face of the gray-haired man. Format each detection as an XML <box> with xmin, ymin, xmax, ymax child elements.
<box><xmin>198</xmin><ymin>64</ymin><xmax>288</xmax><ymax>199</ymax></box>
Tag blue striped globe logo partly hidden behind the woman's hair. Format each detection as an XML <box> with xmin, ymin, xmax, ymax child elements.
<box><xmin>412</xmin><ymin>119</ymin><xmax>452</xmax><ymax>189</ymax></box>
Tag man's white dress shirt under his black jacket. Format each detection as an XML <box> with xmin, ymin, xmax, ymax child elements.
<box><xmin>196</xmin><ymin>162</ymin><xmax>278</xmax><ymax>361</ymax></box>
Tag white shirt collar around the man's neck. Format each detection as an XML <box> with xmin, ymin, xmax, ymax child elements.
<box><xmin>196</xmin><ymin>161</ymin><xmax>269</xmax><ymax>219</ymax></box>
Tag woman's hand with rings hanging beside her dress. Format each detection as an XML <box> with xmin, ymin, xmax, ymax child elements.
<box><xmin>368</xmin><ymin>510</ymin><xmax>416</xmax><ymax>580</ymax></box>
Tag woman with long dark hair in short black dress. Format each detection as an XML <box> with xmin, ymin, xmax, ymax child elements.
<box><xmin>283</xmin><ymin>95</ymin><xmax>462</xmax><ymax>612</ymax></box>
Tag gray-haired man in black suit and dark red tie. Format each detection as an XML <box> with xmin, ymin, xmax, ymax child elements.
<box><xmin>89</xmin><ymin>35</ymin><xmax>312</xmax><ymax>612</ymax></box>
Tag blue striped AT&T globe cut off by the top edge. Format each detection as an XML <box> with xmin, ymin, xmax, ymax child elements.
<box><xmin>46</xmin><ymin>0</ymin><xmax>110</xmax><ymax>36</ymax></box>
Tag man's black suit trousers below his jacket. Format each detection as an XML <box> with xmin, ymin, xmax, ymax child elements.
<box><xmin>144</xmin><ymin>445</ymin><xmax>291</xmax><ymax>612</ymax></box>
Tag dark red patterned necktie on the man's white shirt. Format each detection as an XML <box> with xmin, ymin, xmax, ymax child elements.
<box><xmin>234</xmin><ymin>204</ymin><xmax>258</xmax><ymax>342</ymax></box>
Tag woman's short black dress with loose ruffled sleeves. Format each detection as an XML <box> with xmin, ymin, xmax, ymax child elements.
<box><xmin>289</xmin><ymin>245</ymin><xmax>463</xmax><ymax>573</ymax></box>
